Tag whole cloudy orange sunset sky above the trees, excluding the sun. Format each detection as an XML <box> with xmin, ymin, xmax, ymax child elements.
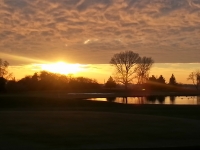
<box><xmin>0</xmin><ymin>0</ymin><xmax>200</xmax><ymax>82</ymax></box>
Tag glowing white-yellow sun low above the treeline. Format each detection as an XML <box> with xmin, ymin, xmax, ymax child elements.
<box><xmin>41</xmin><ymin>62</ymin><xmax>82</xmax><ymax>74</ymax></box>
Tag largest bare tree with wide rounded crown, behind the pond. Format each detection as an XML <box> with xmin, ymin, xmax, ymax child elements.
<box><xmin>110</xmin><ymin>51</ymin><xmax>140</xmax><ymax>89</ymax></box>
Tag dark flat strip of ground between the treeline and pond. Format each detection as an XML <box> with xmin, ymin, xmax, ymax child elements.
<box><xmin>0</xmin><ymin>91</ymin><xmax>200</xmax><ymax>99</ymax></box>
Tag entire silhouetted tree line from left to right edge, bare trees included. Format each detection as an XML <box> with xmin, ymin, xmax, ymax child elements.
<box><xmin>0</xmin><ymin>51</ymin><xmax>200</xmax><ymax>91</ymax></box>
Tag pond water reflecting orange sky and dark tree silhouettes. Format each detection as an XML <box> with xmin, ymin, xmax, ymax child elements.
<box><xmin>88</xmin><ymin>96</ymin><xmax>200</xmax><ymax>105</ymax></box>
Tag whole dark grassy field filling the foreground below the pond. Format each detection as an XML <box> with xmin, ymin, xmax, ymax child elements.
<box><xmin>0</xmin><ymin>93</ymin><xmax>200</xmax><ymax>150</ymax></box>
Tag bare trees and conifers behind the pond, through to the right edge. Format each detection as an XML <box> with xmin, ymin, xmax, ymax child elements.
<box><xmin>106</xmin><ymin>51</ymin><xmax>200</xmax><ymax>90</ymax></box>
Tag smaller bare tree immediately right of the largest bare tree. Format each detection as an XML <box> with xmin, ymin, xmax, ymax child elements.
<box><xmin>135</xmin><ymin>57</ymin><xmax>154</xmax><ymax>84</ymax></box>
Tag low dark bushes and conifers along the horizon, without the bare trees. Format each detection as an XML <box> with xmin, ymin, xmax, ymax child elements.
<box><xmin>0</xmin><ymin>71</ymin><xmax>194</xmax><ymax>92</ymax></box>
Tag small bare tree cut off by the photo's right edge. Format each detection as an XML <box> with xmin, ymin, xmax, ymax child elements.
<box><xmin>187</xmin><ymin>70</ymin><xmax>200</xmax><ymax>90</ymax></box>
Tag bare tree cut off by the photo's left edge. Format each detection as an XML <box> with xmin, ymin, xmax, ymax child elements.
<box><xmin>0</xmin><ymin>59</ymin><xmax>12</xmax><ymax>79</ymax></box>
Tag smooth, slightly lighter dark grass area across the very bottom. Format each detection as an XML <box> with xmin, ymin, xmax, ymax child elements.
<box><xmin>0</xmin><ymin>111</ymin><xmax>200</xmax><ymax>150</ymax></box>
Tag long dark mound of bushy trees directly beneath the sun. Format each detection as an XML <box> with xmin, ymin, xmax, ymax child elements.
<box><xmin>6</xmin><ymin>71</ymin><xmax>100</xmax><ymax>91</ymax></box>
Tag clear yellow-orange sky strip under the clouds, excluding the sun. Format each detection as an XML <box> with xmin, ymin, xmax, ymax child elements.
<box><xmin>10</xmin><ymin>63</ymin><xmax>200</xmax><ymax>83</ymax></box>
